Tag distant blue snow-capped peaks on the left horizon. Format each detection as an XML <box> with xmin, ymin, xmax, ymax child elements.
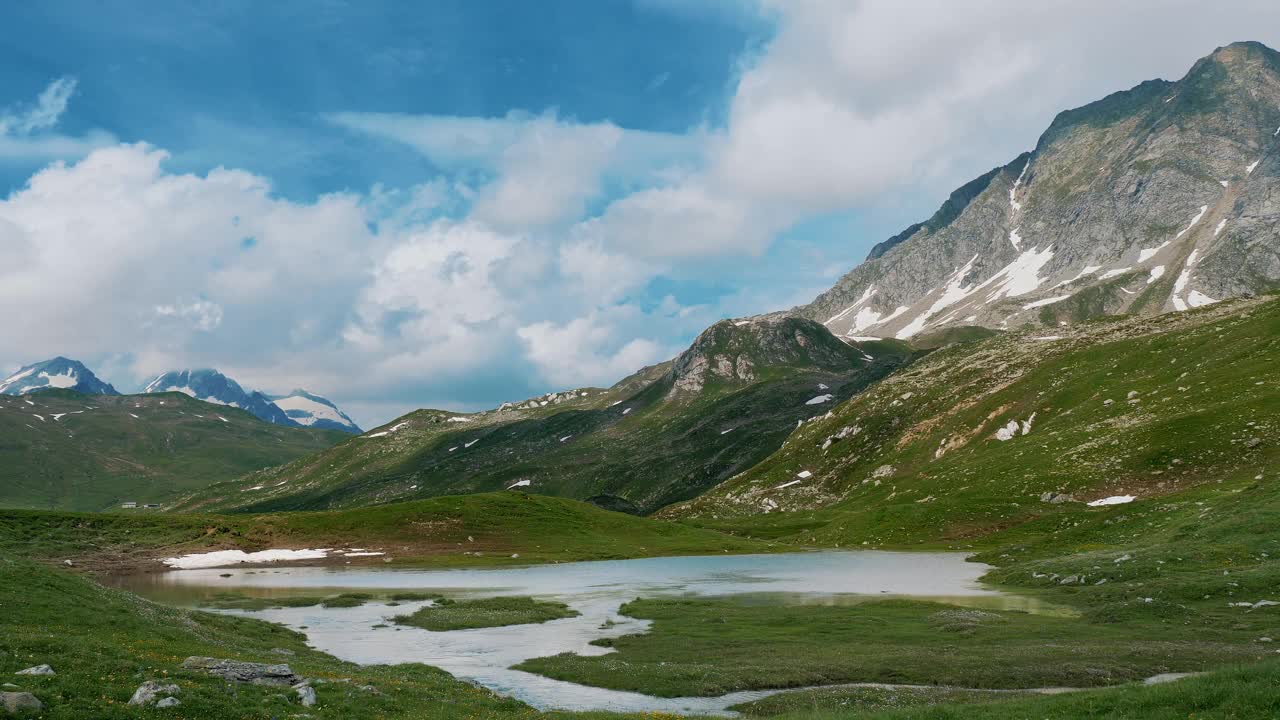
<box><xmin>0</xmin><ymin>356</ymin><xmax>361</xmax><ymax>434</ymax></box>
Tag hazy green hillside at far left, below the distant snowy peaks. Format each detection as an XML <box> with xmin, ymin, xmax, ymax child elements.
<box><xmin>0</xmin><ymin>389</ymin><xmax>346</xmax><ymax>510</ymax></box>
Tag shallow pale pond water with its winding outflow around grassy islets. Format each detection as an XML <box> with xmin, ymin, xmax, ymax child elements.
<box><xmin>118</xmin><ymin>551</ymin><xmax>1041</xmax><ymax>715</ymax></box>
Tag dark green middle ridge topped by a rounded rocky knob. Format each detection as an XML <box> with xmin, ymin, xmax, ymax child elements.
<box><xmin>175</xmin><ymin>318</ymin><xmax>916</xmax><ymax>514</ymax></box>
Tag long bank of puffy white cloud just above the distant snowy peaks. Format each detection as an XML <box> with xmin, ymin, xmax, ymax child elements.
<box><xmin>0</xmin><ymin>145</ymin><xmax>696</xmax><ymax>423</ymax></box>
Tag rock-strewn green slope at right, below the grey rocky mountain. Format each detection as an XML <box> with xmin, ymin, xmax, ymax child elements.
<box><xmin>667</xmin><ymin>297</ymin><xmax>1280</xmax><ymax>546</ymax></box>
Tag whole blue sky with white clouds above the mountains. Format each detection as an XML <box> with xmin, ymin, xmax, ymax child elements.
<box><xmin>0</xmin><ymin>0</ymin><xmax>1280</xmax><ymax>427</ymax></box>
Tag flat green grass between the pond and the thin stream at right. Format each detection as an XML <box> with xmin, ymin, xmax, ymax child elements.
<box><xmin>518</xmin><ymin>598</ymin><xmax>1280</xmax><ymax>697</ymax></box>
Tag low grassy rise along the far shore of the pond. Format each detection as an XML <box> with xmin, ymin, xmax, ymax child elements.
<box><xmin>0</xmin><ymin>492</ymin><xmax>769</xmax><ymax>569</ymax></box>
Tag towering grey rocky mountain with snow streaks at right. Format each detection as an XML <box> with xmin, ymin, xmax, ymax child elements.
<box><xmin>791</xmin><ymin>42</ymin><xmax>1280</xmax><ymax>338</ymax></box>
